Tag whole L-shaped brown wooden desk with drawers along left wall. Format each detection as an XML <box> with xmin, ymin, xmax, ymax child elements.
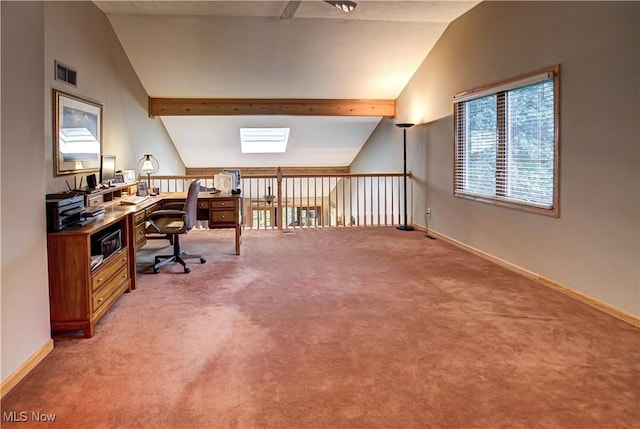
<box><xmin>47</xmin><ymin>192</ymin><xmax>242</xmax><ymax>338</ymax></box>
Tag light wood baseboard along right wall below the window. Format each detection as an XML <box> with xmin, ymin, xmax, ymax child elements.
<box><xmin>414</xmin><ymin>224</ymin><xmax>640</xmax><ymax>328</ymax></box>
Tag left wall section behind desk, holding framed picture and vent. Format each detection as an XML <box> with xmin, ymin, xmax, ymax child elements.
<box><xmin>44</xmin><ymin>1</ymin><xmax>185</xmax><ymax>192</ymax></box>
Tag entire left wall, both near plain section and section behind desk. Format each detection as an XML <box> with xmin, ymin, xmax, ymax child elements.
<box><xmin>0</xmin><ymin>1</ymin><xmax>185</xmax><ymax>382</ymax></box>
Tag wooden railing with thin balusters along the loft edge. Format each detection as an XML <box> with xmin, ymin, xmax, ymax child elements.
<box><xmin>146</xmin><ymin>172</ymin><xmax>413</xmax><ymax>229</ymax></box>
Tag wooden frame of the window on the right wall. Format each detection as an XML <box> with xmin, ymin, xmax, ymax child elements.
<box><xmin>453</xmin><ymin>64</ymin><xmax>560</xmax><ymax>217</ymax></box>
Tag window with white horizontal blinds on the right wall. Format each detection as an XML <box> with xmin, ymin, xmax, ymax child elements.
<box><xmin>454</xmin><ymin>66</ymin><xmax>559</xmax><ymax>216</ymax></box>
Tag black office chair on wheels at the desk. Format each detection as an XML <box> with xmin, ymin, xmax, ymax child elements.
<box><xmin>148</xmin><ymin>180</ymin><xmax>207</xmax><ymax>274</ymax></box>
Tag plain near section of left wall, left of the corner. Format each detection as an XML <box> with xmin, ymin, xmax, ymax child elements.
<box><xmin>0</xmin><ymin>2</ymin><xmax>51</xmax><ymax>381</ymax></box>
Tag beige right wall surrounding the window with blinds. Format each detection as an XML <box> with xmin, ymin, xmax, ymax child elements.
<box><xmin>354</xmin><ymin>2</ymin><xmax>640</xmax><ymax>315</ymax></box>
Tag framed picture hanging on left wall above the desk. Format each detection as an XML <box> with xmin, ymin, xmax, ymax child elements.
<box><xmin>53</xmin><ymin>89</ymin><xmax>102</xmax><ymax>176</ymax></box>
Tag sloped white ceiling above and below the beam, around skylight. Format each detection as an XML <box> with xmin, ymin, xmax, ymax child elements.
<box><xmin>95</xmin><ymin>0</ymin><xmax>478</xmax><ymax>167</ymax></box>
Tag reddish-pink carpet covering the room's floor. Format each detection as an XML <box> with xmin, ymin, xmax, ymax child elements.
<box><xmin>2</xmin><ymin>228</ymin><xmax>640</xmax><ymax>429</ymax></box>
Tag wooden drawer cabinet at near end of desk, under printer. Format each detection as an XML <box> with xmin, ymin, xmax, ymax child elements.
<box><xmin>47</xmin><ymin>212</ymin><xmax>135</xmax><ymax>338</ymax></box>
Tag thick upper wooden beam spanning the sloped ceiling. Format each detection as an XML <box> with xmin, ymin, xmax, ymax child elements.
<box><xmin>149</xmin><ymin>97</ymin><xmax>396</xmax><ymax>118</ymax></box>
